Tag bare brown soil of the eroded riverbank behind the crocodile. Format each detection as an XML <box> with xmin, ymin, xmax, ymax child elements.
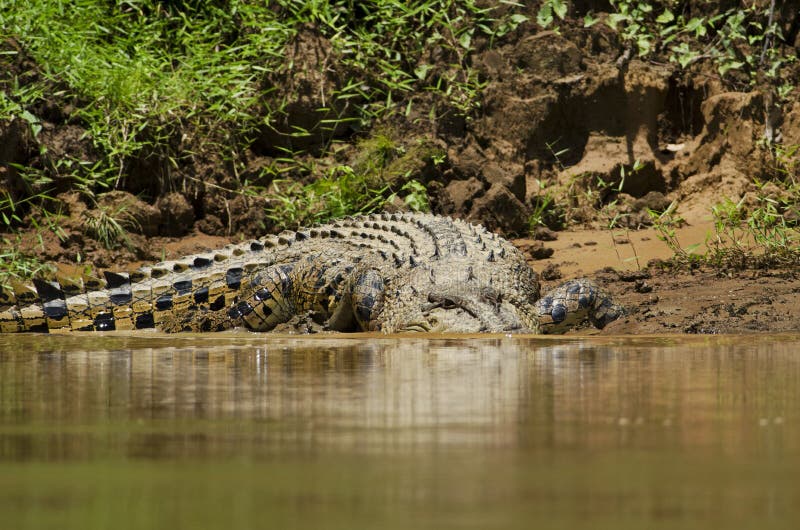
<box><xmin>0</xmin><ymin>3</ymin><xmax>800</xmax><ymax>333</ymax></box>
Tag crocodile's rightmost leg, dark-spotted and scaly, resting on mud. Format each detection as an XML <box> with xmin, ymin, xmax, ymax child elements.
<box><xmin>535</xmin><ymin>278</ymin><xmax>625</xmax><ymax>333</ymax></box>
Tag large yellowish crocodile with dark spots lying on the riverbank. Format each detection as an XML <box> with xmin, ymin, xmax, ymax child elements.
<box><xmin>0</xmin><ymin>213</ymin><xmax>624</xmax><ymax>333</ymax></box>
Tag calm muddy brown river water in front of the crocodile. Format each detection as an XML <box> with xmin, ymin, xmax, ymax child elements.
<box><xmin>0</xmin><ymin>334</ymin><xmax>800</xmax><ymax>529</ymax></box>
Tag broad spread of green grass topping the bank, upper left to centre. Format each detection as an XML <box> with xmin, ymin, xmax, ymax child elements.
<box><xmin>0</xmin><ymin>0</ymin><xmax>524</xmax><ymax>196</ymax></box>
